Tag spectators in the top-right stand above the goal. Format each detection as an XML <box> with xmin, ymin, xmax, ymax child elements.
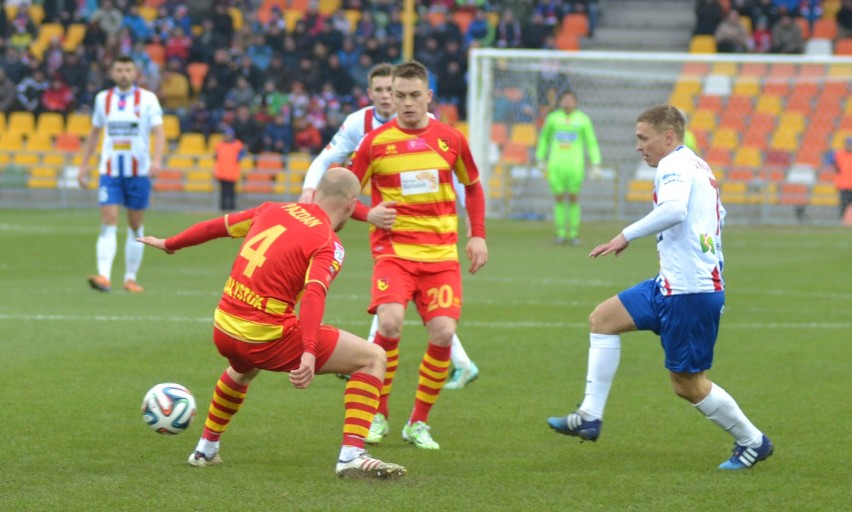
<box><xmin>693</xmin><ymin>0</ymin><xmax>852</xmax><ymax>54</ymax></box>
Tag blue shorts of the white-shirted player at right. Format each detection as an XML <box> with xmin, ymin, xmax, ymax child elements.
<box><xmin>618</xmin><ymin>279</ymin><xmax>725</xmax><ymax>373</ymax></box>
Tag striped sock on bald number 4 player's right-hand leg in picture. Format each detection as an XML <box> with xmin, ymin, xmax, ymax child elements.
<box><xmin>343</xmin><ymin>372</ymin><xmax>382</xmax><ymax>448</ymax></box>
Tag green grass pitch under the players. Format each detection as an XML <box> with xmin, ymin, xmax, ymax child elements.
<box><xmin>0</xmin><ymin>209</ymin><xmax>852</xmax><ymax>511</ymax></box>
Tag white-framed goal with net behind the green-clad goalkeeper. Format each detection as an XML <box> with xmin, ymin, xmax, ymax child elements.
<box><xmin>468</xmin><ymin>49</ymin><xmax>852</xmax><ymax>222</ymax></box>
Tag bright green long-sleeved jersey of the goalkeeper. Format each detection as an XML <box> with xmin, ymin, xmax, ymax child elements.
<box><xmin>535</xmin><ymin>109</ymin><xmax>601</xmax><ymax>171</ymax></box>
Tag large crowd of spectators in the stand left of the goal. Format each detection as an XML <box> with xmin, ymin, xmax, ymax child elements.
<box><xmin>0</xmin><ymin>0</ymin><xmax>597</xmax><ymax>153</ymax></box>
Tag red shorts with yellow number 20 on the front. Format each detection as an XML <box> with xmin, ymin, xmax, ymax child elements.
<box><xmin>368</xmin><ymin>258</ymin><xmax>461</xmax><ymax>323</ymax></box>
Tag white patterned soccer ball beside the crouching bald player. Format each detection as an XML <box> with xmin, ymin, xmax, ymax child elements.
<box><xmin>142</xmin><ymin>382</ymin><xmax>196</xmax><ymax>435</ymax></box>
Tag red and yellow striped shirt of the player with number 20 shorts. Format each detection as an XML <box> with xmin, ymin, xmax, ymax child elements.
<box><xmin>350</xmin><ymin>118</ymin><xmax>484</xmax><ymax>262</ymax></box>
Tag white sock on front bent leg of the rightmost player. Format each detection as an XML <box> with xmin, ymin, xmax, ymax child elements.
<box><xmin>580</xmin><ymin>333</ymin><xmax>621</xmax><ymax>420</ymax></box>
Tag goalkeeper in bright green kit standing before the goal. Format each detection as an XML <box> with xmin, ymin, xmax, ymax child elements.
<box><xmin>535</xmin><ymin>91</ymin><xmax>601</xmax><ymax>245</ymax></box>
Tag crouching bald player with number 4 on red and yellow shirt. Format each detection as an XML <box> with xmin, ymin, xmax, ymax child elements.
<box><xmin>139</xmin><ymin>168</ymin><xmax>406</xmax><ymax>478</ymax></box>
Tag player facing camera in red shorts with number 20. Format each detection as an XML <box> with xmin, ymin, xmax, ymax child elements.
<box><xmin>351</xmin><ymin>61</ymin><xmax>488</xmax><ymax>450</ymax></box>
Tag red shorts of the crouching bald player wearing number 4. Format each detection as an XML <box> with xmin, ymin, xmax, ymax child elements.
<box><xmin>213</xmin><ymin>318</ymin><xmax>340</xmax><ymax>373</ymax></box>
